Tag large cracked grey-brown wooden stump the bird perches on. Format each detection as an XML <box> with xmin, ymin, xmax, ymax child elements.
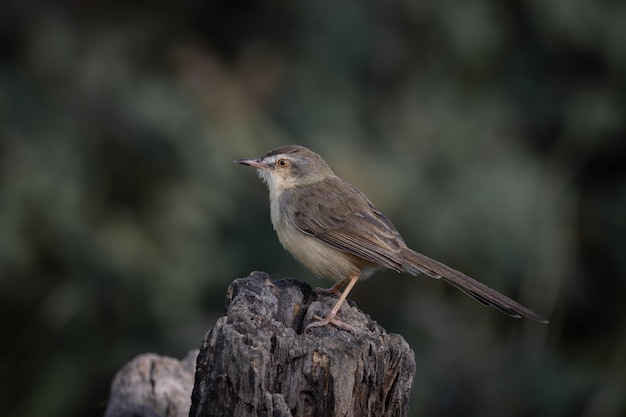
<box><xmin>189</xmin><ymin>272</ymin><xmax>415</xmax><ymax>417</ymax></box>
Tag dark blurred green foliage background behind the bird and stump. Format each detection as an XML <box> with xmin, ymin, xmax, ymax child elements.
<box><xmin>0</xmin><ymin>0</ymin><xmax>626</xmax><ymax>417</ymax></box>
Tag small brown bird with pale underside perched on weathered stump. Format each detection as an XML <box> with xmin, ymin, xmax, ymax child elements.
<box><xmin>235</xmin><ymin>145</ymin><xmax>548</xmax><ymax>329</ymax></box>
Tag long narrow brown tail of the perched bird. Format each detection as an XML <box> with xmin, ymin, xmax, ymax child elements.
<box><xmin>402</xmin><ymin>248</ymin><xmax>548</xmax><ymax>323</ymax></box>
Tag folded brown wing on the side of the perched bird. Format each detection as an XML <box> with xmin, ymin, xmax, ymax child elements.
<box><xmin>294</xmin><ymin>178</ymin><xmax>406</xmax><ymax>272</ymax></box>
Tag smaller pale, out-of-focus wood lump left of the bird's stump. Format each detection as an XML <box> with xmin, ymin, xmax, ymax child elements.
<box><xmin>105</xmin><ymin>349</ymin><xmax>198</xmax><ymax>417</ymax></box>
